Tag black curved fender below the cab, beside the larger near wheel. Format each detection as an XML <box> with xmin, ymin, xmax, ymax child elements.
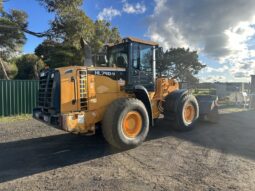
<box><xmin>134</xmin><ymin>85</ymin><xmax>154</xmax><ymax>126</ymax></box>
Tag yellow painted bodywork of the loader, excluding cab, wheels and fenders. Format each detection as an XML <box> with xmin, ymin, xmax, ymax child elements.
<box><xmin>55</xmin><ymin>66</ymin><xmax>179</xmax><ymax>133</ymax></box>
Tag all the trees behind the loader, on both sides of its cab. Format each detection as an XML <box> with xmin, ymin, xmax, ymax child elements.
<box><xmin>0</xmin><ymin>0</ymin><xmax>205</xmax><ymax>81</ymax></box>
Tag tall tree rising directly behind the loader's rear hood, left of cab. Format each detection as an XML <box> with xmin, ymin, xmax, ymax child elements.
<box><xmin>35</xmin><ymin>0</ymin><xmax>120</xmax><ymax>67</ymax></box>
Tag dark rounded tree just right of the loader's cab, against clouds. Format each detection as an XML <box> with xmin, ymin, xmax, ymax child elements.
<box><xmin>157</xmin><ymin>48</ymin><xmax>206</xmax><ymax>82</ymax></box>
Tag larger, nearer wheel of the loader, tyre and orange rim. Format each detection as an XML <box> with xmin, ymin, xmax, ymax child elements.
<box><xmin>102</xmin><ymin>98</ymin><xmax>149</xmax><ymax>149</ymax></box>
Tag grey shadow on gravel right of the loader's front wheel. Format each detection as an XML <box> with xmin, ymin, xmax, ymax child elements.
<box><xmin>157</xmin><ymin>111</ymin><xmax>255</xmax><ymax>160</ymax></box>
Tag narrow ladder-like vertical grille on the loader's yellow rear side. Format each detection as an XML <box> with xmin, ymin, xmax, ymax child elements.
<box><xmin>79</xmin><ymin>70</ymin><xmax>88</xmax><ymax>111</ymax></box>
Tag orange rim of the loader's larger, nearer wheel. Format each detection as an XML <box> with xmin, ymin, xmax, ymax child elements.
<box><xmin>122</xmin><ymin>111</ymin><xmax>142</xmax><ymax>138</ymax></box>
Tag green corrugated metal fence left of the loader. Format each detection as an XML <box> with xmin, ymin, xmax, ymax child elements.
<box><xmin>0</xmin><ymin>80</ymin><xmax>39</xmax><ymax>116</ymax></box>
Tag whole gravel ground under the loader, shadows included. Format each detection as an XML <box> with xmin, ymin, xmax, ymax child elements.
<box><xmin>0</xmin><ymin>109</ymin><xmax>255</xmax><ymax>191</ymax></box>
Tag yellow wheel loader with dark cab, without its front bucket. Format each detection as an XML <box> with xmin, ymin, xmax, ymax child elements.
<box><xmin>33</xmin><ymin>37</ymin><xmax>199</xmax><ymax>149</ymax></box>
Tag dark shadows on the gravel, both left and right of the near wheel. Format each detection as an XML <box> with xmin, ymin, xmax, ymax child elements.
<box><xmin>0</xmin><ymin>109</ymin><xmax>255</xmax><ymax>183</ymax></box>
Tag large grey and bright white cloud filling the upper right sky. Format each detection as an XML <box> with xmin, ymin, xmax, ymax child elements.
<box><xmin>147</xmin><ymin>0</ymin><xmax>255</xmax><ymax>80</ymax></box>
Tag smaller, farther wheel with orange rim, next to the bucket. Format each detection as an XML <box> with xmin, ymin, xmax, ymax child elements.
<box><xmin>164</xmin><ymin>94</ymin><xmax>199</xmax><ymax>131</ymax></box>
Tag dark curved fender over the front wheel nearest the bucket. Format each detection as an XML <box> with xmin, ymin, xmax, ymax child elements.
<box><xmin>163</xmin><ymin>89</ymin><xmax>188</xmax><ymax>112</ymax></box>
